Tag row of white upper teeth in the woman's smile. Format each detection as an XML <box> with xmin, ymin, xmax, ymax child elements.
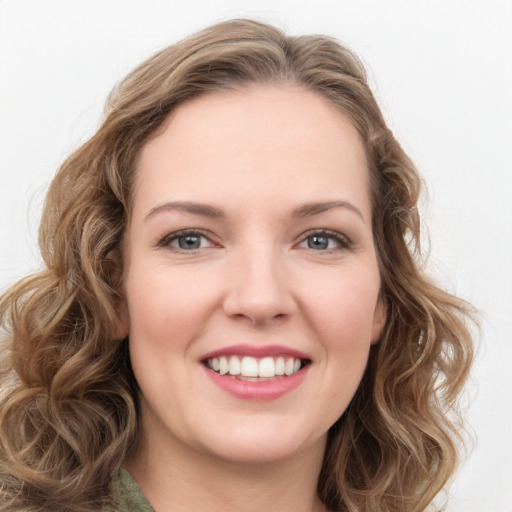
<box><xmin>206</xmin><ymin>355</ymin><xmax>302</xmax><ymax>377</ymax></box>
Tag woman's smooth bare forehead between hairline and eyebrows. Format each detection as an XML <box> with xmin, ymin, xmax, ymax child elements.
<box><xmin>134</xmin><ymin>85</ymin><xmax>371</xmax><ymax>220</ymax></box>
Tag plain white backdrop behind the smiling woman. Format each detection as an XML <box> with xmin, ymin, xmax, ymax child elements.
<box><xmin>0</xmin><ymin>0</ymin><xmax>512</xmax><ymax>512</ymax></box>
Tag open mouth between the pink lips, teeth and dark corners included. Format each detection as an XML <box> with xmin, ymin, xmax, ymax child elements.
<box><xmin>202</xmin><ymin>354</ymin><xmax>311</xmax><ymax>382</ymax></box>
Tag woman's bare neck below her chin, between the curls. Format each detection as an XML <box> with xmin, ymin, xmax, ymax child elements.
<box><xmin>124</xmin><ymin>426</ymin><xmax>327</xmax><ymax>512</ymax></box>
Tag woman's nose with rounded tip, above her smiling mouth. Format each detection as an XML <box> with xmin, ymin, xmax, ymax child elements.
<box><xmin>223</xmin><ymin>246</ymin><xmax>297</xmax><ymax>325</ymax></box>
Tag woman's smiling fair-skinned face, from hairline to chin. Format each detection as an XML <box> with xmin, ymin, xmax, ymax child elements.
<box><xmin>124</xmin><ymin>85</ymin><xmax>385</xmax><ymax>462</ymax></box>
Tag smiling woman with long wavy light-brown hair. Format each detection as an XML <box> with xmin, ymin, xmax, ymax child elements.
<box><xmin>0</xmin><ymin>20</ymin><xmax>472</xmax><ymax>512</ymax></box>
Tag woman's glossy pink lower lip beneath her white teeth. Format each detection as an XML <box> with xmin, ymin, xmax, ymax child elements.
<box><xmin>204</xmin><ymin>365</ymin><xmax>309</xmax><ymax>400</ymax></box>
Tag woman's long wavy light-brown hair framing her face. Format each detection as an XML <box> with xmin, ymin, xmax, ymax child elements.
<box><xmin>0</xmin><ymin>20</ymin><xmax>473</xmax><ymax>512</ymax></box>
